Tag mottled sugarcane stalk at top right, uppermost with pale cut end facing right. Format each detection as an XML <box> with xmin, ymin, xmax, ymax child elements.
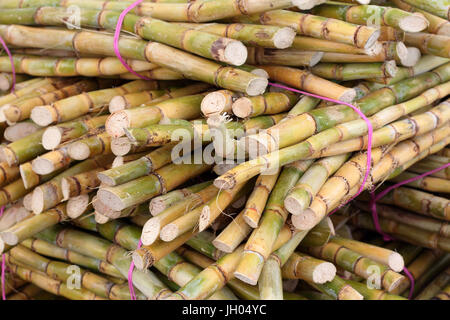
<box><xmin>312</xmin><ymin>4</ymin><xmax>428</xmax><ymax>32</ymax></box>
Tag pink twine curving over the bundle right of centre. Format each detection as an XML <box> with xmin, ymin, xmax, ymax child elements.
<box><xmin>269</xmin><ymin>82</ymin><xmax>373</xmax><ymax>210</ymax></box>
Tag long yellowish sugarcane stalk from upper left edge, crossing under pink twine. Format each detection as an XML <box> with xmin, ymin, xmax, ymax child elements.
<box><xmin>0</xmin><ymin>26</ymin><xmax>267</xmax><ymax>95</ymax></box>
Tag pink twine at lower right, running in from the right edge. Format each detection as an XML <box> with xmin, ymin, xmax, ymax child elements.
<box><xmin>370</xmin><ymin>163</ymin><xmax>450</xmax><ymax>299</ymax></box>
